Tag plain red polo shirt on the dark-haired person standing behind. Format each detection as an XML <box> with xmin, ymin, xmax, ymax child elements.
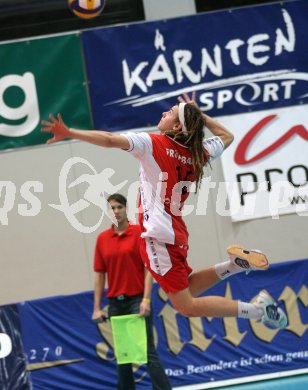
<box><xmin>94</xmin><ymin>224</ymin><xmax>144</xmax><ymax>298</ymax></box>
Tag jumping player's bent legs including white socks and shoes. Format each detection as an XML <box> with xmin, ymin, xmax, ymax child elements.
<box><xmin>177</xmin><ymin>245</ymin><xmax>288</xmax><ymax>329</ymax></box>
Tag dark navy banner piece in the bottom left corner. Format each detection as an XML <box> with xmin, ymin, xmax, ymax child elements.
<box><xmin>0</xmin><ymin>305</ymin><xmax>31</xmax><ymax>390</ymax></box>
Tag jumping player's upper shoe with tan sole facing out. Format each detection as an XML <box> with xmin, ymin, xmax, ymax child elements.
<box><xmin>227</xmin><ymin>245</ymin><xmax>269</xmax><ymax>272</ymax></box>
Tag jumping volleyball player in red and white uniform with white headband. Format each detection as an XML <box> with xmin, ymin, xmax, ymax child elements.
<box><xmin>42</xmin><ymin>94</ymin><xmax>287</xmax><ymax>328</ymax></box>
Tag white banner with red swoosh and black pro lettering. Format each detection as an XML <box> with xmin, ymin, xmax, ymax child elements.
<box><xmin>220</xmin><ymin>105</ymin><xmax>308</xmax><ymax>221</ymax></box>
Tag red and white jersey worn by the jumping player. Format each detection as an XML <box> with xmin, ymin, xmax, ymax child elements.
<box><xmin>122</xmin><ymin>133</ymin><xmax>224</xmax><ymax>245</ymax></box>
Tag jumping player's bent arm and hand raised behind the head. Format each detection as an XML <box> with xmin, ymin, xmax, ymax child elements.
<box><xmin>178</xmin><ymin>92</ymin><xmax>234</xmax><ymax>149</ymax></box>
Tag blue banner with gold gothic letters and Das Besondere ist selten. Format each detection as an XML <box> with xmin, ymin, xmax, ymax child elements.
<box><xmin>12</xmin><ymin>259</ymin><xmax>308</xmax><ymax>390</ymax></box>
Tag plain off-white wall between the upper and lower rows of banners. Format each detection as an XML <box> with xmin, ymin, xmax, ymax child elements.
<box><xmin>0</xmin><ymin>134</ymin><xmax>308</xmax><ymax>304</ymax></box>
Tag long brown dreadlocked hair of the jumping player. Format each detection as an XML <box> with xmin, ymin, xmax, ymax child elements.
<box><xmin>165</xmin><ymin>103</ymin><xmax>209</xmax><ymax>192</ymax></box>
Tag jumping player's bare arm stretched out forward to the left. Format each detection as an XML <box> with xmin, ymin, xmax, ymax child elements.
<box><xmin>41</xmin><ymin>114</ymin><xmax>130</xmax><ymax>149</ymax></box>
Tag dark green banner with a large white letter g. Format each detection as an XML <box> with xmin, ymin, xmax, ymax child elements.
<box><xmin>0</xmin><ymin>34</ymin><xmax>91</xmax><ymax>149</ymax></box>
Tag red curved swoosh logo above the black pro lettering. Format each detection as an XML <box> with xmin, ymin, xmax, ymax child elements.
<box><xmin>234</xmin><ymin>114</ymin><xmax>308</xmax><ymax>165</ymax></box>
